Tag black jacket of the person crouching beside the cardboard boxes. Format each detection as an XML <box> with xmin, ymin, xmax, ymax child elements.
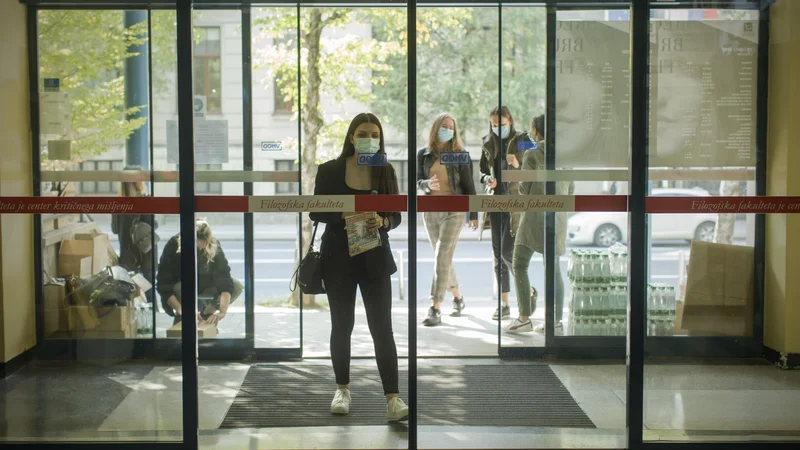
<box><xmin>156</xmin><ymin>235</ymin><xmax>234</xmax><ymax>301</ymax></box>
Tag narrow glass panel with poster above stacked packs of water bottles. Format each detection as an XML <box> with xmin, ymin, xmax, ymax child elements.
<box><xmin>548</xmin><ymin>10</ymin><xmax>630</xmax><ymax>342</ymax></box>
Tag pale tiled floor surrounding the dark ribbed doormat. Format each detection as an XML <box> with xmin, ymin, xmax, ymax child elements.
<box><xmin>0</xmin><ymin>359</ymin><xmax>800</xmax><ymax>449</ymax></box>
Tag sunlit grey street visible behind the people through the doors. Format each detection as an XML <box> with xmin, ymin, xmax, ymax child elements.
<box><xmin>100</xmin><ymin>216</ymin><xmax>745</xmax><ymax>357</ymax></box>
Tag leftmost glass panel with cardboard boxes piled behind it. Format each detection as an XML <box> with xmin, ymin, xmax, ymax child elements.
<box><xmin>0</xmin><ymin>10</ymin><xmax>183</xmax><ymax>442</ymax></box>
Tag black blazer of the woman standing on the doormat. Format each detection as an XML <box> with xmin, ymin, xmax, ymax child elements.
<box><xmin>309</xmin><ymin>158</ymin><xmax>402</xmax><ymax>285</ymax></box>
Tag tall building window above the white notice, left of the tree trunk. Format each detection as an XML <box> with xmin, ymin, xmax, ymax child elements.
<box><xmin>194</xmin><ymin>27</ymin><xmax>222</xmax><ymax>114</ymax></box>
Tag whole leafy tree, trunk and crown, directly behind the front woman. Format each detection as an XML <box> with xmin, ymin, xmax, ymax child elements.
<box><xmin>254</xmin><ymin>8</ymin><xmax>405</xmax><ymax>303</ymax></box>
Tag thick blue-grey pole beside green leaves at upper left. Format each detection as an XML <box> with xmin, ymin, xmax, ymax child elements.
<box><xmin>123</xmin><ymin>11</ymin><xmax>150</xmax><ymax>170</ymax></box>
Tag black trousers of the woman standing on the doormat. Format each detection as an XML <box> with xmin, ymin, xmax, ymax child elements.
<box><xmin>326</xmin><ymin>271</ymin><xmax>399</xmax><ymax>394</ymax></box>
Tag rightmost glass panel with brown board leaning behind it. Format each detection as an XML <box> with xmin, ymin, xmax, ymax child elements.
<box><xmin>644</xmin><ymin>9</ymin><xmax>800</xmax><ymax>442</ymax></box>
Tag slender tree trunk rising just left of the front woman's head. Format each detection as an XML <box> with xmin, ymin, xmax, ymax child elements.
<box><xmin>291</xmin><ymin>8</ymin><xmax>325</xmax><ymax>305</ymax></box>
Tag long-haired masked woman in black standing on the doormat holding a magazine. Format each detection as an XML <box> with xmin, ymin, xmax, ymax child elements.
<box><xmin>310</xmin><ymin>113</ymin><xmax>408</xmax><ymax>422</ymax></box>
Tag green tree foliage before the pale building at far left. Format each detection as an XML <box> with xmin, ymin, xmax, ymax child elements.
<box><xmin>38</xmin><ymin>10</ymin><xmax>176</xmax><ymax>169</ymax></box>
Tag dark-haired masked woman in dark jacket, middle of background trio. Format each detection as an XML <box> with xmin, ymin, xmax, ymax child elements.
<box><xmin>480</xmin><ymin>106</ymin><xmax>521</xmax><ymax>320</ymax></box>
